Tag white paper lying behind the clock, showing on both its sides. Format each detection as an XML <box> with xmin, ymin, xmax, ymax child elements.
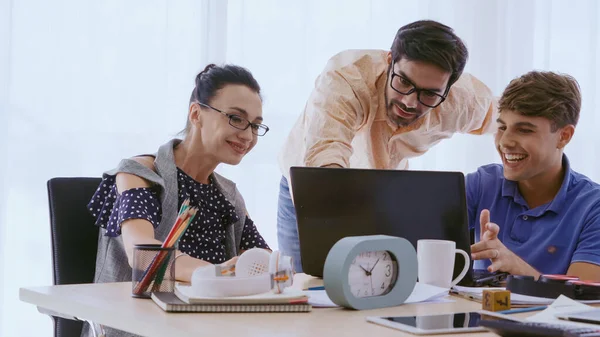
<box><xmin>304</xmin><ymin>282</ymin><xmax>451</xmax><ymax>308</ymax></box>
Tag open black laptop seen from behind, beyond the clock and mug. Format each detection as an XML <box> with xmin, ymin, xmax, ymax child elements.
<box><xmin>290</xmin><ymin>167</ymin><xmax>489</xmax><ymax>286</ymax></box>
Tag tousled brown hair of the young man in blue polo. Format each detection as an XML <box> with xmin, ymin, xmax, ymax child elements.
<box><xmin>498</xmin><ymin>71</ymin><xmax>581</xmax><ymax>132</ymax></box>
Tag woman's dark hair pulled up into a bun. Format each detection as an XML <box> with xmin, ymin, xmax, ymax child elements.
<box><xmin>182</xmin><ymin>63</ymin><xmax>260</xmax><ymax>134</ymax></box>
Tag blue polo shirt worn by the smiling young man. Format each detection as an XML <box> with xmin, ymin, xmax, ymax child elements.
<box><xmin>466</xmin><ymin>156</ymin><xmax>600</xmax><ymax>274</ymax></box>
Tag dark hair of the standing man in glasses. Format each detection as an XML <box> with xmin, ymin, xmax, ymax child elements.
<box><xmin>391</xmin><ymin>20</ymin><xmax>469</xmax><ymax>88</ymax></box>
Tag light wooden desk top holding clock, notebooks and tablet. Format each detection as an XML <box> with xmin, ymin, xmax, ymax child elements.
<box><xmin>19</xmin><ymin>276</ymin><xmax>528</xmax><ymax>337</ymax></box>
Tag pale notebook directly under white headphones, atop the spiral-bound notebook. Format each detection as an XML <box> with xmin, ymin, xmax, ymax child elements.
<box><xmin>175</xmin><ymin>284</ymin><xmax>308</xmax><ymax>304</ymax></box>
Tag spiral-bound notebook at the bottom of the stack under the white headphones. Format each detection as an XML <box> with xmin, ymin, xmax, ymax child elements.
<box><xmin>151</xmin><ymin>292</ymin><xmax>312</xmax><ymax>312</ymax></box>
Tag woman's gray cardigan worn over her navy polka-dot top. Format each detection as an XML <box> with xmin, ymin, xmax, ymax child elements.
<box><xmin>84</xmin><ymin>139</ymin><xmax>247</xmax><ymax>337</ymax></box>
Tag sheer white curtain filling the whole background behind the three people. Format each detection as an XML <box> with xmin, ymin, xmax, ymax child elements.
<box><xmin>0</xmin><ymin>0</ymin><xmax>600</xmax><ymax>336</ymax></box>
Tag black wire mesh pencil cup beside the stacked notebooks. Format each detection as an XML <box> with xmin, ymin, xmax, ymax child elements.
<box><xmin>131</xmin><ymin>244</ymin><xmax>175</xmax><ymax>298</ymax></box>
